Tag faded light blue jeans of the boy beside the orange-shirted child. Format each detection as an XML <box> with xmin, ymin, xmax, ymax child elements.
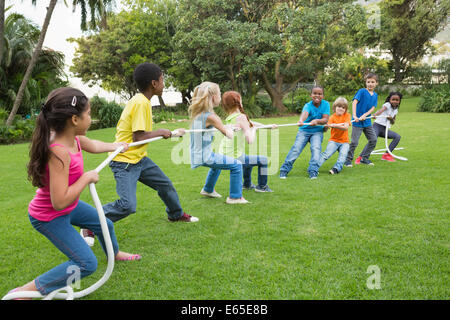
<box><xmin>280</xmin><ymin>130</ymin><xmax>323</xmax><ymax>175</ymax></box>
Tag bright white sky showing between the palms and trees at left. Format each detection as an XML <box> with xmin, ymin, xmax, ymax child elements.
<box><xmin>6</xmin><ymin>0</ymin><xmax>181</xmax><ymax>105</ymax></box>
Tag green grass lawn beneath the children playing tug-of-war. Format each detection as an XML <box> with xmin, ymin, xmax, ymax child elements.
<box><xmin>0</xmin><ymin>98</ymin><xmax>450</xmax><ymax>300</ymax></box>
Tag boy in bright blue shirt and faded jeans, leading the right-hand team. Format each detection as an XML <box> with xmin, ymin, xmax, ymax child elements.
<box><xmin>280</xmin><ymin>86</ymin><xmax>330</xmax><ymax>179</ymax></box>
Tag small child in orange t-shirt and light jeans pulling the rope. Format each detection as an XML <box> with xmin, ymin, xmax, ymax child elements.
<box><xmin>317</xmin><ymin>97</ymin><xmax>351</xmax><ymax>174</ymax></box>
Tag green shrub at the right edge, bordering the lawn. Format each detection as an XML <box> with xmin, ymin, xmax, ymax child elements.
<box><xmin>417</xmin><ymin>84</ymin><xmax>450</xmax><ymax>113</ymax></box>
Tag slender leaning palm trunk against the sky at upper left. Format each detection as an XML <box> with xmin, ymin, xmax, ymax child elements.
<box><xmin>6</xmin><ymin>0</ymin><xmax>58</xmax><ymax>126</ymax></box>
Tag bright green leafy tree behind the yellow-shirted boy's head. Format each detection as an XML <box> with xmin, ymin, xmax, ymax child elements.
<box><xmin>70</xmin><ymin>1</ymin><xmax>175</xmax><ymax>104</ymax></box>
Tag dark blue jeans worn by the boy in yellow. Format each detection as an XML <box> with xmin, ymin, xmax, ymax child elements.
<box><xmin>103</xmin><ymin>157</ymin><xmax>183</xmax><ymax>222</ymax></box>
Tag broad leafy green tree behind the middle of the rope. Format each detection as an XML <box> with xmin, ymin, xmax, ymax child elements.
<box><xmin>174</xmin><ymin>0</ymin><xmax>356</xmax><ymax>111</ymax></box>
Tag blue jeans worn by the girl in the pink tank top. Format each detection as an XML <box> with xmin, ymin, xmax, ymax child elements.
<box><xmin>29</xmin><ymin>200</ymin><xmax>119</xmax><ymax>295</ymax></box>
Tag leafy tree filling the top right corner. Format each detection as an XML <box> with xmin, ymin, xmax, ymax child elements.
<box><xmin>380</xmin><ymin>0</ymin><xmax>450</xmax><ymax>82</ymax></box>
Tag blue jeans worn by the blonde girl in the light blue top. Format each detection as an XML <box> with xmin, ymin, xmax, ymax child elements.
<box><xmin>203</xmin><ymin>153</ymin><xmax>242</xmax><ymax>199</ymax></box>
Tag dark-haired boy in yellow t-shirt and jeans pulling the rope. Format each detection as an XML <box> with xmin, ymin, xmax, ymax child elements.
<box><xmin>81</xmin><ymin>63</ymin><xmax>198</xmax><ymax>245</ymax></box>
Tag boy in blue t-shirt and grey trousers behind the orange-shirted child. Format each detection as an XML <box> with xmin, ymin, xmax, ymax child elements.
<box><xmin>344</xmin><ymin>73</ymin><xmax>378</xmax><ymax>167</ymax></box>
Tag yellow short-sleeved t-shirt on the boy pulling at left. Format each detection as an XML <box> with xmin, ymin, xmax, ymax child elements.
<box><xmin>114</xmin><ymin>93</ymin><xmax>153</xmax><ymax>164</ymax></box>
